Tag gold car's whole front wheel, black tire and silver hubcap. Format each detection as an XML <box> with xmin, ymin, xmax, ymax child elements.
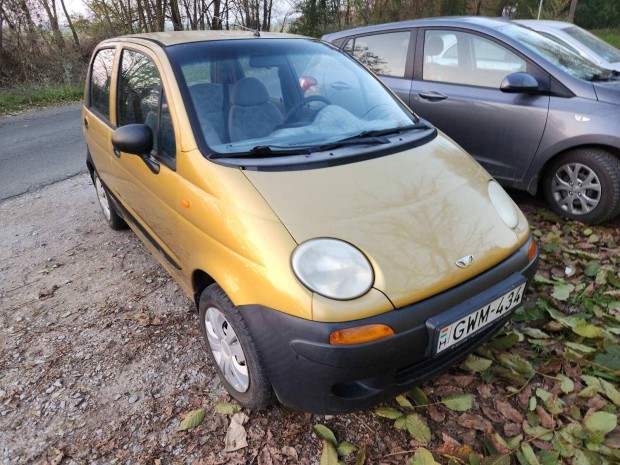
<box><xmin>199</xmin><ymin>284</ymin><xmax>273</xmax><ymax>410</ymax></box>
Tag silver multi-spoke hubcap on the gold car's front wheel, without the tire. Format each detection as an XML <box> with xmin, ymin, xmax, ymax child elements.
<box><xmin>205</xmin><ymin>307</ymin><xmax>250</xmax><ymax>392</ymax></box>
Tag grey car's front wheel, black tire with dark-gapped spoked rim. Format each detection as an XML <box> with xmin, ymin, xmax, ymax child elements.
<box><xmin>543</xmin><ymin>148</ymin><xmax>620</xmax><ymax>224</ymax></box>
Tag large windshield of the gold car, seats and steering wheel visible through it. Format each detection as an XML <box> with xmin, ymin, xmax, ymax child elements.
<box><xmin>168</xmin><ymin>38</ymin><xmax>418</xmax><ymax>156</ymax></box>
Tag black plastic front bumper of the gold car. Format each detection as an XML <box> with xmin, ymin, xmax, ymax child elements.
<box><xmin>238</xmin><ymin>239</ymin><xmax>538</xmax><ymax>414</ymax></box>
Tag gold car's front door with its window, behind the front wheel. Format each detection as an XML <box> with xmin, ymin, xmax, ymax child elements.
<box><xmin>110</xmin><ymin>45</ymin><xmax>180</xmax><ymax>269</ymax></box>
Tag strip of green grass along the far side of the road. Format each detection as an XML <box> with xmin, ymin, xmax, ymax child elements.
<box><xmin>0</xmin><ymin>84</ymin><xmax>84</xmax><ymax>115</ymax></box>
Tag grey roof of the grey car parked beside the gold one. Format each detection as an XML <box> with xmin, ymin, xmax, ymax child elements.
<box><xmin>323</xmin><ymin>16</ymin><xmax>508</xmax><ymax>41</ymax></box>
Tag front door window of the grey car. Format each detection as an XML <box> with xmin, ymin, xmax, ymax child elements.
<box><xmin>422</xmin><ymin>30</ymin><xmax>527</xmax><ymax>89</ymax></box>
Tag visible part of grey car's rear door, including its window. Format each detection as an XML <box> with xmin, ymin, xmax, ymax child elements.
<box><xmin>343</xmin><ymin>29</ymin><xmax>415</xmax><ymax>104</ymax></box>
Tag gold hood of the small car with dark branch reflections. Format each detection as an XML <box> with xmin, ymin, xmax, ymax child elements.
<box><xmin>245</xmin><ymin>135</ymin><xmax>529</xmax><ymax>308</ymax></box>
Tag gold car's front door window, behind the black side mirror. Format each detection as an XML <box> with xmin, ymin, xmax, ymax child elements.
<box><xmin>117</xmin><ymin>49</ymin><xmax>176</xmax><ymax>164</ymax></box>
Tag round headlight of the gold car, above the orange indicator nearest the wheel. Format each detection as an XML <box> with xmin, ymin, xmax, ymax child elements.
<box><xmin>291</xmin><ymin>239</ymin><xmax>375</xmax><ymax>300</ymax></box>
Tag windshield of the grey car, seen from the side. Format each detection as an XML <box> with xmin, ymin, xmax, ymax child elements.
<box><xmin>498</xmin><ymin>24</ymin><xmax>609</xmax><ymax>80</ymax></box>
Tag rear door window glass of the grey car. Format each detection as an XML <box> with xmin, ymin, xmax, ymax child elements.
<box><xmin>352</xmin><ymin>31</ymin><xmax>411</xmax><ymax>77</ymax></box>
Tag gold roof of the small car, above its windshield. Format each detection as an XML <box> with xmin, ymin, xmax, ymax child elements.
<box><xmin>105</xmin><ymin>31</ymin><xmax>304</xmax><ymax>47</ymax></box>
